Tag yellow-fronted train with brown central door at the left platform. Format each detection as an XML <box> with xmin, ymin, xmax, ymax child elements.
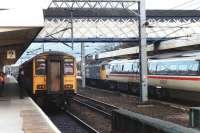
<box><xmin>20</xmin><ymin>51</ymin><xmax>77</xmax><ymax>106</ymax></box>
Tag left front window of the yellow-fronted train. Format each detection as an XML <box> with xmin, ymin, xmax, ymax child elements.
<box><xmin>35</xmin><ymin>59</ymin><xmax>46</xmax><ymax>75</ymax></box>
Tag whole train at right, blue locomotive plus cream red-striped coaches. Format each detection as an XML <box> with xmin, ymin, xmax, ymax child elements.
<box><xmin>86</xmin><ymin>57</ymin><xmax>200</xmax><ymax>102</ymax></box>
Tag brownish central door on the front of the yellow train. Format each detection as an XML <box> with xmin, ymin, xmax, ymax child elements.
<box><xmin>48</xmin><ymin>58</ymin><xmax>63</xmax><ymax>92</ymax></box>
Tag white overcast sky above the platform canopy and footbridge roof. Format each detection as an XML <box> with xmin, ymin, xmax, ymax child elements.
<box><xmin>0</xmin><ymin>0</ymin><xmax>200</xmax><ymax>9</ymax></box>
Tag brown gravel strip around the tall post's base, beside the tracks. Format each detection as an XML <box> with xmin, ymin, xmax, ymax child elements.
<box><xmin>78</xmin><ymin>88</ymin><xmax>189</xmax><ymax>126</ymax></box>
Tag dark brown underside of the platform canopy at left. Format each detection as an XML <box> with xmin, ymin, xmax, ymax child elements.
<box><xmin>0</xmin><ymin>27</ymin><xmax>41</xmax><ymax>65</ymax></box>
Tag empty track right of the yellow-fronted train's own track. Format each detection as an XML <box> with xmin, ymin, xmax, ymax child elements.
<box><xmin>73</xmin><ymin>94</ymin><xmax>118</xmax><ymax>119</ymax></box>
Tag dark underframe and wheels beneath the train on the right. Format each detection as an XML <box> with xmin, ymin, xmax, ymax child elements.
<box><xmin>86</xmin><ymin>78</ymin><xmax>200</xmax><ymax>103</ymax></box>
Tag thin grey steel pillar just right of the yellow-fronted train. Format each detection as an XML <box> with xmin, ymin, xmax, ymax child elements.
<box><xmin>81</xmin><ymin>42</ymin><xmax>85</xmax><ymax>88</ymax></box>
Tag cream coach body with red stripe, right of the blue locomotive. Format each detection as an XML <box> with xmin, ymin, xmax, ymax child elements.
<box><xmin>87</xmin><ymin>58</ymin><xmax>200</xmax><ymax>99</ymax></box>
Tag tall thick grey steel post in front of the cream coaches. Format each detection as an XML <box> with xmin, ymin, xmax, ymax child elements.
<box><xmin>138</xmin><ymin>0</ymin><xmax>148</xmax><ymax>104</ymax></box>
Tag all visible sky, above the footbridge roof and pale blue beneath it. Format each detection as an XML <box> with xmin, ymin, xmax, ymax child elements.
<box><xmin>0</xmin><ymin>0</ymin><xmax>200</xmax><ymax>64</ymax></box>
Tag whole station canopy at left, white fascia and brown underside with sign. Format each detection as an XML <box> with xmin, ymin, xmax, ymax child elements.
<box><xmin>0</xmin><ymin>9</ymin><xmax>44</xmax><ymax>66</ymax></box>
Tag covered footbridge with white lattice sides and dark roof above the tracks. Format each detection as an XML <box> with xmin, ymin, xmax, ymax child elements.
<box><xmin>35</xmin><ymin>0</ymin><xmax>200</xmax><ymax>43</ymax></box>
